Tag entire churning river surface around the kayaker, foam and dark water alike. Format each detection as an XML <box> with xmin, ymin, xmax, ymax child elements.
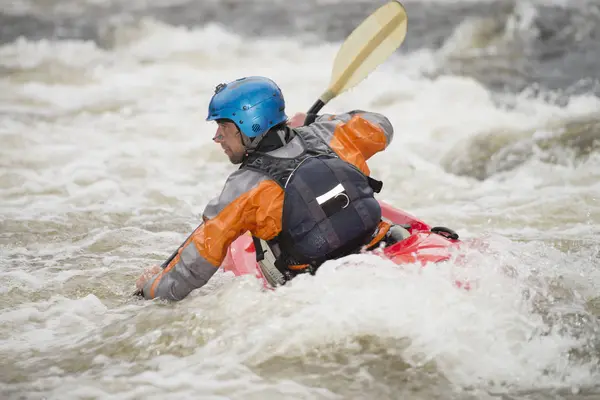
<box><xmin>0</xmin><ymin>0</ymin><xmax>600</xmax><ymax>400</ymax></box>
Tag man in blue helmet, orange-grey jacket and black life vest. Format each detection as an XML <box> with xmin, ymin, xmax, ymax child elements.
<box><xmin>136</xmin><ymin>77</ymin><xmax>408</xmax><ymax>300</ymax></box>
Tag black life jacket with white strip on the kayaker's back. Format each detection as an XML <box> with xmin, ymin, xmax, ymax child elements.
<box><xmin>240</xmin><ymin>131</ymin><xmax>382</xmax><ymax>279</ymax></box>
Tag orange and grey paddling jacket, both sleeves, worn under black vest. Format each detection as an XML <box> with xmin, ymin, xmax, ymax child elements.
<box><xmin>143</xmin><ymin>111</ymin><xmax>393</xmax><ymax>300</ymax></box>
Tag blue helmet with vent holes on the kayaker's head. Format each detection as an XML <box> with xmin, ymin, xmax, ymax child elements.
<box><xmin>206</xmin><ymin>76</ymin><xmax>287</xmax><ymax>138</ymax></box>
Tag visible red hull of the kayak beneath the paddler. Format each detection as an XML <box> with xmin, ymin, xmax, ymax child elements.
<box><xmin>222</xmin><ymin>201</ymin><xmax>463</xmax><ymax>287</ymax></box>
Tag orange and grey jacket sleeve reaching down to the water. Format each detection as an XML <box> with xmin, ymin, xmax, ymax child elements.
<box><xmin>143</xmin><ymin>170</ymin><xmax>283</xmax><ymax>301</ymax></box>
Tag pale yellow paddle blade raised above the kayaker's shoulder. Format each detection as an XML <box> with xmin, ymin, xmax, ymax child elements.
<box><xmin>320</xmin><ymin>1</ymin><xmax>408</xmax><ymax>103</ymax></box>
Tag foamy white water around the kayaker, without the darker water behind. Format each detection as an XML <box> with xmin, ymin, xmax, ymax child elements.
<box><xmin>0</xmin><ymin>12</ymin><xmax>600</xmax><ymax>399</ymax></box>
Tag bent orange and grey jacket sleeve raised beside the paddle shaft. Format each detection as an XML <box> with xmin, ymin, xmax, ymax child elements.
<box><xmin>309</xmin><ymin>110</ymin><xmax>394</xmax><ymax>175</ymax></box>
